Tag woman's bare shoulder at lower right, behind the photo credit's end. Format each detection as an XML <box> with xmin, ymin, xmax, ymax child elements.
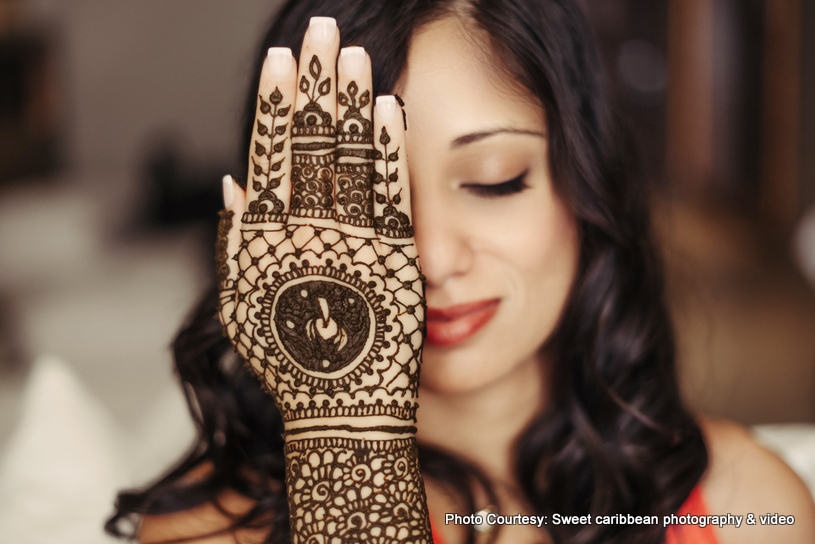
<box><xmin>700</xmin><ymin>418</ymin><xmax>815</xmax><ymax>544</ymax></box>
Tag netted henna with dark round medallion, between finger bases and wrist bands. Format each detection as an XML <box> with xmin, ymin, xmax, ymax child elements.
<box><xmin>233</xmin><ymin>225</ymin><xmax>425</xmax><ymax>423</ymax></box>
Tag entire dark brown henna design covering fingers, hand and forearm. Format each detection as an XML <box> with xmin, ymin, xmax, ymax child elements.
<box><xmin>216</xmin><ymin>43</ymin><xmax>432</xmax><ymax>544</ymax></box>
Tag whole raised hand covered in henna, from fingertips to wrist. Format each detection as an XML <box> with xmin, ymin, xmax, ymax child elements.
<box><xmin>217</xmin><ymin>19</ymin><xmax>425</xmax><ymax>438</ymax></box>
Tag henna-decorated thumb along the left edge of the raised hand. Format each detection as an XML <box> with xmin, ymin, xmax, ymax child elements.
<box><xmin>215</xmin><ymin>176</ymin><xmax>246</xmax><ymax>339</ymax></box>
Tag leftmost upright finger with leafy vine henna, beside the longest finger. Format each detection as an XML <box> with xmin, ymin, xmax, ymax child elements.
<box><xmin>243</xmin><ymin>47</ymin><xmax>297</xmax><ymax>223</ymax></box>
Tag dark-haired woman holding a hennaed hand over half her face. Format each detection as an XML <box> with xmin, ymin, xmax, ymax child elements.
<box><xmin>108</xmin><ymin>0</ymin><xmax>815</xmax><ymax>544</ymax></box>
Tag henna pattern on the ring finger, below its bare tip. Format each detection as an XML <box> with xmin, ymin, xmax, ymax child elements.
<box><xmin>336</xmin><ymin>81</ymin><xmax>374</xmax><ymax>227</ymax></box>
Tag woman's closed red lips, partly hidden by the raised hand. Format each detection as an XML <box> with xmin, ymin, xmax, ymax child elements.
<box><xmin>427</xmin><ymin>299</ymin><xmax>501</xmax><ymax>346</ymax></box>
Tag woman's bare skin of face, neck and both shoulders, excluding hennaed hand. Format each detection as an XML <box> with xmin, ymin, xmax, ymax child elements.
<box><xmin>141</xmin><ymin>13</ymin><xmax>815</xmax><ymax>544</ymax></box>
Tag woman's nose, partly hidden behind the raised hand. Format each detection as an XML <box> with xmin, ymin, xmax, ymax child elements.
<box><xmin>411</xmin><ymin>191</ymin><xmax>474</xmax><ymax>289</ymax></box>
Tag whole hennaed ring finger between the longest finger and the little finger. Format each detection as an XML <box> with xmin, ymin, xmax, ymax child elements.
<box><xmin>335</xmin><ymin>47</ymin><xmax>374</xmax><ymax>238</ymax></box>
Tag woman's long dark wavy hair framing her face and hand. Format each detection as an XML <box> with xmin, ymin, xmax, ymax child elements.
<box><xmin>106</xmin><ymin>0</ymin><xmax>708</xmax><ymax>544</ymax></box>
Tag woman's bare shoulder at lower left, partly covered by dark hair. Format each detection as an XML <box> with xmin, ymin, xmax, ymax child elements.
<box><xmin>139</xmin><ymin>468</ymin><xmax>267</xmax><ymax>544</ymax></box>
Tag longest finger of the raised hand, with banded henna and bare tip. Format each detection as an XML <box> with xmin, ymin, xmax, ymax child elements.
<box><xmin>291</xmin><ymin>17</ymin><xmax>340</xmax><ymax>218</ymax></box>
